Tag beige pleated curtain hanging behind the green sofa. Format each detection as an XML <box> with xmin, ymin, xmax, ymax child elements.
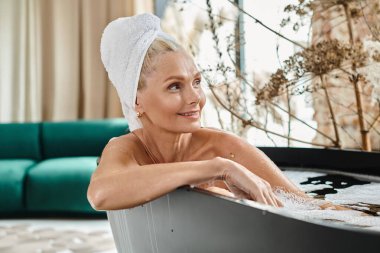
<box><xmin>0</xmin><ymin>0</ymin><xmax>153</xmax><ymax>122</ymax></box>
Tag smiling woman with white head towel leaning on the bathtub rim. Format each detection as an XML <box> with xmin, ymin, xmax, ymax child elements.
<box><xmin>88</xmin><ymin>14</ymin><xmax>316</xmax><ymax>210</ymax></box>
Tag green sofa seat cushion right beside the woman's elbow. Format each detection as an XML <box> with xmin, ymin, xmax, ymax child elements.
<box><xmin>26</xmin><ymin>156</ymin><xmax>97</xmax><ymax>213</ymax></box>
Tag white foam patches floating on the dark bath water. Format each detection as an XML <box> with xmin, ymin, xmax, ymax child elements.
<box><xmin>236</xmin><ymin>171</ymin><xmax>380</xmax><ymax>231</ymax></box>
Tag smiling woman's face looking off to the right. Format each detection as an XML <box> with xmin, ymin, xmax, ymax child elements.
<box><xmin>136</xmin><ymin>52</ymin><xmax>206</xmax><ymax>132</ymax></box>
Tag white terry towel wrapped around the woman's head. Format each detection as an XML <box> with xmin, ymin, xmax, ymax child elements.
<box><xmin>100</xmin><ymin>13</ymin><xmax>174</xmax><ymax>131</ymax></box>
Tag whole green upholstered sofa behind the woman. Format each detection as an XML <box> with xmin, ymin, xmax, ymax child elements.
<box><xmin>0</xmin><ymin>119</ymin><xmax>129</xmax><ymax>216</ymax></box>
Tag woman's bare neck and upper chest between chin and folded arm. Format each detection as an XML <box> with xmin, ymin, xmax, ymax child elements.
<box><xmin>136</xmin><ymin>128</ymin><xmax>192</xmax><ymax>163</ymax></box>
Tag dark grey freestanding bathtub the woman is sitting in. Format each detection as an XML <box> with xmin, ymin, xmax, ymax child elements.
<box><xmin>107</xmin><ymin>148</ymin><xmax>380</xmax><ymax>253</ymax></box>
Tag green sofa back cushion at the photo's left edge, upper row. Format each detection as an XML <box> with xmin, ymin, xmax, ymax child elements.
<box><xmin>0</xmin><ymin>123</ymin><xmax>41</xmax><ymax>160</ymax></box>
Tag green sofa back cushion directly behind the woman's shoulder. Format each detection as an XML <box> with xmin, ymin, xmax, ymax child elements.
<box><xmin>42</xmin><ymin>119</ymin><xmax>129</xmax><ymax>159</ymax></box>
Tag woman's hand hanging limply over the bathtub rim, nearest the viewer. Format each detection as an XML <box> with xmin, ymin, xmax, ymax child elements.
<box><xmin>215</xmin><ymin>157</ymin><xmax>283</xmax><ymax>207</ymax></box>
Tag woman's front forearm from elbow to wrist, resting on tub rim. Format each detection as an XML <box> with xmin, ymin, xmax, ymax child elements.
<box><xmin>87</xmin><ymin>159</ymin><xmax>221</xmax><ymax>210</ymax></box>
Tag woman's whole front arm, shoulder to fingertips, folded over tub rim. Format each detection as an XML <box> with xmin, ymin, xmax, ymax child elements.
<box><xmin>87</xmin><ymin>134</ymin><xmax>281</xmax><ymax>210</ymax></box>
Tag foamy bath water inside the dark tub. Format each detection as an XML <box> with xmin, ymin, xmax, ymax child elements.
<box><xmin>276</xmin><ymin>169</ymin><xmax>380</xmax><ymax>231</ymax></box>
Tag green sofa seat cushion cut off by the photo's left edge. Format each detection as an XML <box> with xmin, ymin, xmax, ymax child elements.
<box><xmin>0</xmin><ymin>159</ymin><xmax>36</xmax><ymax>212</ymax></box>
